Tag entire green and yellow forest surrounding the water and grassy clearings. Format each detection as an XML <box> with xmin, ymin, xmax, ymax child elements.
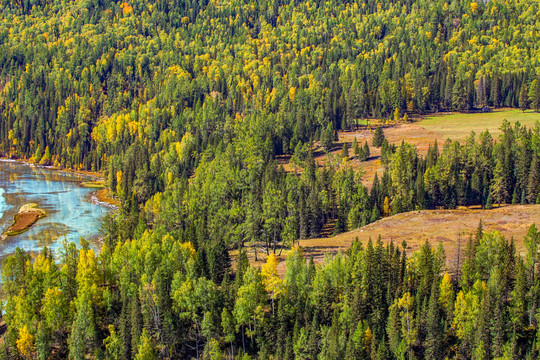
<box><xmin>0</xmin><ymin>0</ymin><xmax>540</xmax><ymax>360</ymax></box>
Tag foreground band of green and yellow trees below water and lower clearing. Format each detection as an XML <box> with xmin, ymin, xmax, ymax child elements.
<box><xmin>0</xmin><ymin>223</ymin><xmax>540</xmax><ymax>360</ymax></box>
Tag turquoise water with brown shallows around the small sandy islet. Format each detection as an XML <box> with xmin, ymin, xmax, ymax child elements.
<box><xmin>0</xmin><ymin>161</ymin><xmax>109</xmax><ymax>260</ymax></box>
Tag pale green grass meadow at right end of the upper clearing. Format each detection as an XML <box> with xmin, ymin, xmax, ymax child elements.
<box><xmin>422</xmin><ymin>109</ymin><xmax>540</xmax><ymax>141</ymax></box>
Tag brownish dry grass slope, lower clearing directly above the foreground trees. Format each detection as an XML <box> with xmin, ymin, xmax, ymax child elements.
<box><xmin>300</xmin><ymin>205</ymin><xmax>540</xmax><ymax>270</ymax></box>
